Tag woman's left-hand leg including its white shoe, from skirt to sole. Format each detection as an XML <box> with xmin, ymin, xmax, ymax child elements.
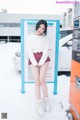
<box><xmin>31</xmin><ymin>65</ymin><xmax>44</xmax><ymax>116</ymax></box>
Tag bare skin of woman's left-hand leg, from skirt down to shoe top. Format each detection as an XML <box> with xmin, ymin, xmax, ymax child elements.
<box><xmin>31</xmin><ymin>65</ymin><xmax>41</xmax><ymax>100</ymax></box>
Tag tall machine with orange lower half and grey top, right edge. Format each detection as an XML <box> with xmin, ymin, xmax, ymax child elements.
<box><xmin>69</xmin><ymin>17</ymin><xmax>80</xmax><ymax>120</ymax></box>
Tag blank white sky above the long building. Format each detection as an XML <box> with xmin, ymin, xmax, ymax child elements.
<box><xmin>0</xmin><ymin>0</ymin><xmax>73</xmax><ymax>14</ymax></box>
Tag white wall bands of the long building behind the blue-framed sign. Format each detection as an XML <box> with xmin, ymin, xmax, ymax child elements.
<box><xmin>0</xmin><ymin>13</ymin><xmax>62</xmax><ymax>36</ymax></box>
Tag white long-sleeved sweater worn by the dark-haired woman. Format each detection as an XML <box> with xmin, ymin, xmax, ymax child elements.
<box><xmin>27</xmin><ymin>33</ymin><xmax>49</xmax><ymax>66</ymax></box>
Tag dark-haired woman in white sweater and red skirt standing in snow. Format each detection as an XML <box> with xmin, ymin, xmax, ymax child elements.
<box><xmin>27</xmin><ymin>19</ymin><xmax>50</xmax><ymax>116</ymax></box>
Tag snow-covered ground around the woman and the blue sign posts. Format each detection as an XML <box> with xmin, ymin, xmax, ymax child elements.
<box><xmin>0</xmin><ymin>43</ymin><xmax>70</xmax><ymax>120</ymax></box>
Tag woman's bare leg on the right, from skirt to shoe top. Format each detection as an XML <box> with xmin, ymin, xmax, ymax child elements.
<box><xmin>40</xmin><ymin>62</ymin><xmax>49</xmax><ymax>97</ymax></box>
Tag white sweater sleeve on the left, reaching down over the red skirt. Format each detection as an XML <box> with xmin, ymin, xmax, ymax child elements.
<box><xmin>27</xmin><ymin>41</ymin><xmax>38</xmax><ymax>66</ymax></box>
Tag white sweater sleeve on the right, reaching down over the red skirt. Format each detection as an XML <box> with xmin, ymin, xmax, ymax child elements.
<box><xmin>39</xmin><ymin>43</ymin><xmax>49</xmax><ymax>65</ymax></box>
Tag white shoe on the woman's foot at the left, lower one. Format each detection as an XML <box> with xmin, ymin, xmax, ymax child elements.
<box><xmin>36</xmin><ymin>100</ymin><xmax>44</xmax><ymax>117</ymax></box>
